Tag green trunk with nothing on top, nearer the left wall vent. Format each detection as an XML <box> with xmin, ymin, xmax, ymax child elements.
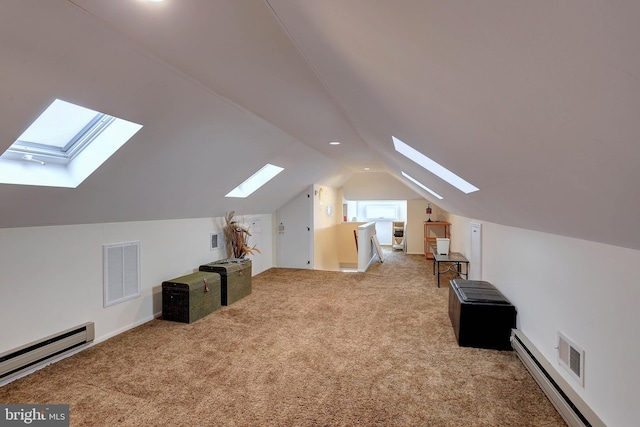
<box><xmin>162</xmin><ymin>271</ymin><xmax>221</xmax><ymax>323</ymax></box>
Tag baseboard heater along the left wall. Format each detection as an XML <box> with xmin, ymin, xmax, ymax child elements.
<box><xmin>0</xmin><ymin>322</ymin><xmax>95</xmax><ymax>384</ymax></box>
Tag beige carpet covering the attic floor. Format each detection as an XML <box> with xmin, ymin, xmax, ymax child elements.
<box><xmin>0</xmin><ymin>248</ymin><xmax>565</xmax><ymax>426</ymax></box>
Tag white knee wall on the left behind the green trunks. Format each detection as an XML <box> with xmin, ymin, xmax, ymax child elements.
<box><xmin>0</xmin><ymin>215</ymin><xmax>273</xmax><ymax>353</ymax></box>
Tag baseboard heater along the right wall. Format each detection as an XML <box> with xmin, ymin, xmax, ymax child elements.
<box><xmin>511</xmin><ymin>329</ymin><xmax>606</xmax><ymax>427</ymax></box>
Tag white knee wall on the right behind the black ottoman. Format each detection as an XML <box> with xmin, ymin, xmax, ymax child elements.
<box><xmin>450</xmin><ymin>215</ymin><xmax>640</xmax><ymax>427</ymax></box>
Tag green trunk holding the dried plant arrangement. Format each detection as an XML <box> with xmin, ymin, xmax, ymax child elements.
<box><xmin>200</xmin><ymin>258</ymin><xmax>251</xmax><ymax>305</ymax></box>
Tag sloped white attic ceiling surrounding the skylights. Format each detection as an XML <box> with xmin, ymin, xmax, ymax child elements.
<box><xmin>0</xmin><ymin>0</ymin><xmax>640</xmax><ymax>249</ymax></box>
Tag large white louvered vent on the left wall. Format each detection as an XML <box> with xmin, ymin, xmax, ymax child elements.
<box><xmin>103</xmin><ymin>242</ymin><xmax>140</xmax><ymax>307</ymax></box>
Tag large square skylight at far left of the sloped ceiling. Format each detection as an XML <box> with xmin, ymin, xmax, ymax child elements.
<box><xmin>0</xmin><ymin>99</ymin><xmax>142</xmax><ymax>188</ymax></box>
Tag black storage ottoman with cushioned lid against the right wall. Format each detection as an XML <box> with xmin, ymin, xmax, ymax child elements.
<box><xmin>449</xmin><ymin>279</ymin><xmax>516</xmax><ymax>350</ymax></box>
